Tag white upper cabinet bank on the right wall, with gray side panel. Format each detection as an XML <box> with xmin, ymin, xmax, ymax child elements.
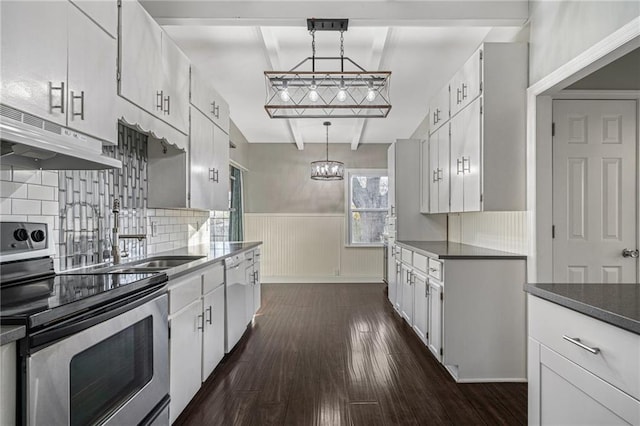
<box><xmin>422</xmin><ymin>43</ymin><xmax>528</xmax><ymax>213</ymax></box>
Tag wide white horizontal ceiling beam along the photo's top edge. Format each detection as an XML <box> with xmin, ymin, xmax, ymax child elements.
<box><xmin>141</xmin><ymin>0</ymin><xmax>529</xmax><ymax>27</ymax></box>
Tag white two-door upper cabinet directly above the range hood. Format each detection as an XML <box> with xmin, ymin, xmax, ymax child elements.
<box><xmin>0</xmin><ymin>1</ymin><xmax>117</xmax><ymax>144</ymax></box>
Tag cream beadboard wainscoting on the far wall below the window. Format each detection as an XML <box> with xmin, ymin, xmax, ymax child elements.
<box><xmin>244</xmin><ymin>213</ymin><xmax>382</xmax><ymax>283</ymax></box>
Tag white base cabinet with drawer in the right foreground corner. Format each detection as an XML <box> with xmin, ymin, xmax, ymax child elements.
<box><xmin>528</xmin><ymin>296</ymin><xmax>640</xmax><ymax>425</ymax></box>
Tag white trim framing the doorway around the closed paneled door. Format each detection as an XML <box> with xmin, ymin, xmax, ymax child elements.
<box><xmin>526</xmin><ymin>17</ymin><xmax>640</xmax><ymax>283</ymax></box>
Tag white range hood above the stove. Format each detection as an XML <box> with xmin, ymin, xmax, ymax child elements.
<box><xmin>0</xmin><ymin>105</ymin><xmax>122</xmax><ymax>170</ymax></box>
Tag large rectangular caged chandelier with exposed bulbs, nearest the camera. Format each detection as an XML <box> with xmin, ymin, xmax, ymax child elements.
<box><xmin>264</xmin><ymin>19</ymin><xmax>391</xmax><ymax>118</ymax></box>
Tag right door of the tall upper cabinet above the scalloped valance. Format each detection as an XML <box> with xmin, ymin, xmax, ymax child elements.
<box><xmin>159</xmin><ymin>33</ymin><xmax>189</xmax><ymax>133</ymax></box>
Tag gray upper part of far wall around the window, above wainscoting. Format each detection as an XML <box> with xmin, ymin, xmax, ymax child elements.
<box><xmin>245</xmin><ymin>143</ymin><xmax>389</xmax><ymax>213</ymax></box>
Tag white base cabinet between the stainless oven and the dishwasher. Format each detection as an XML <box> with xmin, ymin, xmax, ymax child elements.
<box><xmin>169</xmin><ymin>263</ymin><xmax>225</xmax><ymax>423</ymax></box>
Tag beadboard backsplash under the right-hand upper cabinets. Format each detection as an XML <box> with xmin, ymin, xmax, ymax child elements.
<box><xmin>449</xmin><ymin>211</ymin><xmax>529</xmax><ymax>254</ymax></box>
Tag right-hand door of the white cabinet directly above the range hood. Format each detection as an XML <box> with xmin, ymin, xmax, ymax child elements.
<box><xmin>67</xmin><ymin>6</ymin><xmax>118</xmax><ymax>145</ymax></box>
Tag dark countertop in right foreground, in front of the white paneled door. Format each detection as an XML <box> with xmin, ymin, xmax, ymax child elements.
<box><xmin>525</xmin><ymin>284</ymin><xmax>640</xmax><ymax>334</ymax></box>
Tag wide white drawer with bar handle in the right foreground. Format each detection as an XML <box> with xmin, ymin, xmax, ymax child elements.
<box><xmin>528</xmin><ymin>296</ymin><xmax>640</xmax><ymax>399</ymax></box>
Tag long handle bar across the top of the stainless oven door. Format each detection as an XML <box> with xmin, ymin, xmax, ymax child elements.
<box><xmin>29</xmin><ymin>282</ymin><xmax>167</xmax><ymax>354</ymax></box>
